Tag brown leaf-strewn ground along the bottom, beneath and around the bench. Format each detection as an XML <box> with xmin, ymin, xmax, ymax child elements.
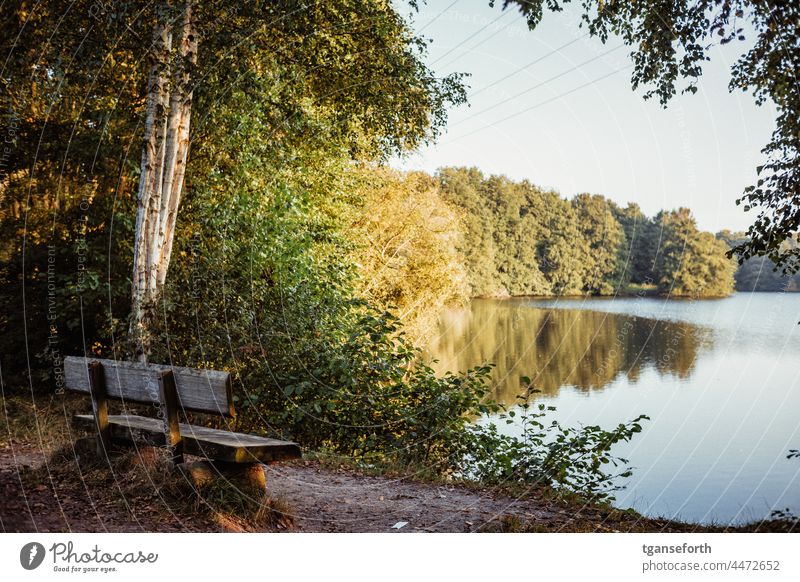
<box><xmin>0</xmin><ymin>400</ymin><xmax>797</xmax><ymax>533</ymax></box>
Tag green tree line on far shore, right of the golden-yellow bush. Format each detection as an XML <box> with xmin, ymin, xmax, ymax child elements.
<box><xmin>437</xmin><ymin>168</ymin><xmax>736</xmax><ymax>297</ymax></box>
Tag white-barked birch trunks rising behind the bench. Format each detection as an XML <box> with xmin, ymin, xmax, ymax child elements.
<box><xmin>129</xmin><ymin>0</ymin><xmax>197</xmax><ymax>361</ymax></box>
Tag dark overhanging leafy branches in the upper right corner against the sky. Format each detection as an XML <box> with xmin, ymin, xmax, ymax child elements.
<box><xmin>500</xmin><ymin>0</ymin><xmax>800</xmax><ymax>273</ymax></box>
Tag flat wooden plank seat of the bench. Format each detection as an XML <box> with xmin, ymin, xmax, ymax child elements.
<box><xmin>73</xmin><ymin>414</ymin><xmax>301</xmax><ymax>463</ymax></box>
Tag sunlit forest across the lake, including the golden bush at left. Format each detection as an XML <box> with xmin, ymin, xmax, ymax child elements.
<box><xmin>354</xmin><ymin>168</ymin><xmax>800</xmax><ymax>340</ymax></box>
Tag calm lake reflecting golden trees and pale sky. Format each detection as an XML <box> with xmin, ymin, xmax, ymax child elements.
<box><xmin>429</xmin><ymin>293</ymin><xmax>800</xmax><ymax>524</ymax></box>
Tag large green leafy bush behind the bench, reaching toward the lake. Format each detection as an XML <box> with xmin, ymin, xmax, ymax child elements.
<box><xmin>136</xmin><ymin>120</ymin><xmax>638</xmax><ymax>496</ymax></box>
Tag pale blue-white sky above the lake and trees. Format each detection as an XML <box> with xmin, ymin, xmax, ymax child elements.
<box><xmin>392</xmin><ymin>0</ymin><xmax>776</xmax><ymax>232</ymax></box>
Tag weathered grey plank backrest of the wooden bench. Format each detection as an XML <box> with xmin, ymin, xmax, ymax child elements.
<box><xmin>64</xmin><ymin>356</ymin><xmax>236</xmax><ymax>418</ymax></box>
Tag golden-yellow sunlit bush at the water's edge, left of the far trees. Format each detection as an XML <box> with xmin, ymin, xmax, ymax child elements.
<box><xmin>348</xmin><ymin>168</ymin><xmax>469</xmax><ymax>343</ymax></box>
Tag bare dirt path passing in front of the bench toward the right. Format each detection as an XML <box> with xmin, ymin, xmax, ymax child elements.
<box><xmin>0</xmin><ymin>440</ymin><xmax>704</xmax><ymax>532</ymax></box>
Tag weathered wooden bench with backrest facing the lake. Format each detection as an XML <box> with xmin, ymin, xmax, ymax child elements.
<box><xmin>64</xmin><ymin>356</ymin><xmax>301</xmax><ymax>490</ymax></box>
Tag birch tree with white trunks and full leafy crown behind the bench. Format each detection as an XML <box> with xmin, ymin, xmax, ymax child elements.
<box><xmin>0</xmin><ymin>0</ymin><xmax>464</xmax><ymax>360</ymax></box>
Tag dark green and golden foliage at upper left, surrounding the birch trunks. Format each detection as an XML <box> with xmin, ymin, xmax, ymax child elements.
<box><xmin>0</xmin><ymin>0</ymin><xmax>464</xmax><ymax>378</ymax></box>
